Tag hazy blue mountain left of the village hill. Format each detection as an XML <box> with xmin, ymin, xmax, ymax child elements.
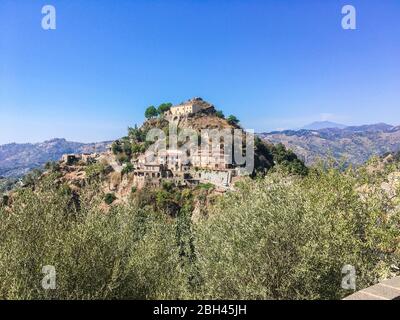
<box><xmin>0</xmin><ymin>139</ymin><xmax>111</xmax><ymax>177</ymax></box>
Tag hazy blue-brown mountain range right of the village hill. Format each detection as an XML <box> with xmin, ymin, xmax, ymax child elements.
<box><xmin>259</xmin><ymin>123</ymin><xmax>400</xmax><ymax>164</ymax></box>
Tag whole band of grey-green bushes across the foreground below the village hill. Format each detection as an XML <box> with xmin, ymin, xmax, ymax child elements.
<box><xmin>0</xmin><ymin>160</ymin><xmax>400</xmax><ymax>299</ymax></box>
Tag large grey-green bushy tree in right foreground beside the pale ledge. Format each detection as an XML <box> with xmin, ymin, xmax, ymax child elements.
<box><xmin>196</xmin><ymin>169</ymin><xmax>400</xmax><ymax>299</ymax></box>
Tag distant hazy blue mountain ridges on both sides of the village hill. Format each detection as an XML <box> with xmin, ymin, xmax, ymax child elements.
<box><xmin>0</xmin><ymin>122</ymin><xmax>400</xmax><ymax>178</ymax></box>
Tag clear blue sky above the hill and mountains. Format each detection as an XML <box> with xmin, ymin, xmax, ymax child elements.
<box><xmin>0</xmin><ymin>0</ymin><xmax>400</xmax><ymax>144</ymax></box>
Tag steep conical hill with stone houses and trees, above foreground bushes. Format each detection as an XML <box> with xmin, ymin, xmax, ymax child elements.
<box><xmin>28</xmin><ymin>98</ymin><xmax>307</xmax><ymax>209</ymax></box>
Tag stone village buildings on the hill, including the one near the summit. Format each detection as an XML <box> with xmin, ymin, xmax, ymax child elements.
<box><xmin>132</xmin><ymin>98</ymin><xmax>250</xmax><ymax>189</ymax></box>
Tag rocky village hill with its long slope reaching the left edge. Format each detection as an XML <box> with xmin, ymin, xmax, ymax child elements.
<box><xmin>0</xmin><ymin>98</ymin><xmax>308</xmax><ymax>221</ymax></box>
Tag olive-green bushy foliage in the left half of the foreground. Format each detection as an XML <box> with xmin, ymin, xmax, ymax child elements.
<box><xmin>0</xmin><ymin>186</ymin><xmax>186</xmax><ymax>300</ymax></box>
